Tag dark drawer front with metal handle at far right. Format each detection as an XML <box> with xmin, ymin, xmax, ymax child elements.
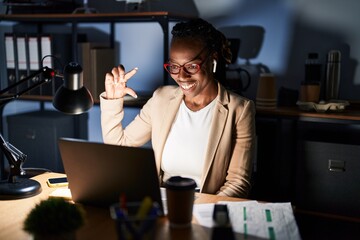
<box><xmin>296</xmin><ymin>141</ymin><xmax>360</xmax><ymax>217</ymax></box>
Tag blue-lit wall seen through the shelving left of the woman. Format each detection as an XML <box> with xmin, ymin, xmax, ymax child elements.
<box><xmin>0</xmin><ymin>20</ymin><xmax>167</xmax><ymax>142</ymax></box>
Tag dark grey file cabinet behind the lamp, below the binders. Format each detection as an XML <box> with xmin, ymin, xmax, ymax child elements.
<box><xmin>7</xmin><ymin>111</ymin><xmax>87</xmax><ymax>172</ymax></box>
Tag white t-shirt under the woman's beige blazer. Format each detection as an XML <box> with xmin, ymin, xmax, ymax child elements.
<box><xmin>161</xmin><ymin>100</ymin><xmax>215</xmax><ymax>187</ymax></box>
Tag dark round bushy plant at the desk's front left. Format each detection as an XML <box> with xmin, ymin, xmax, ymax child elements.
<box><xmin>23</xmin><ymin>198</ymin><xmax>85</xmax><ymax>240</ymax></box>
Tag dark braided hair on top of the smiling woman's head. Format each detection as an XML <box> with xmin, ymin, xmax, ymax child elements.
<box><xmin>171</xmin><ymin>18</ymin><xmax>232</xmax><ymax>63</ymax></box>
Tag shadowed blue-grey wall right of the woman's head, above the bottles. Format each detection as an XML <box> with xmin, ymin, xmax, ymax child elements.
<box><xmin>204</xmin><ymin>0</ymin><xmax>360</xmax><ymax>100</ymax></box>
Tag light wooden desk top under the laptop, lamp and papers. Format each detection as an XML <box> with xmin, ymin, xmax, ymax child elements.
<box><xmin>0</xmin><ymin>173</ymin><xmax>246</xmax><ymax>240</ymax></box>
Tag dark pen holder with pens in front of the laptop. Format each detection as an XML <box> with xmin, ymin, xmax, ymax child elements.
<box><xmin>110</xmin><ymin>202</ymin><xmax>161</xmax><ymax>240</ymax></box>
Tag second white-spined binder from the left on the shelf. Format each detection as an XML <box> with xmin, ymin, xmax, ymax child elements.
<box><xmin>16</xmin><ymin>35</ymin><xmax>29</xmax><ymax>92</ymax></box>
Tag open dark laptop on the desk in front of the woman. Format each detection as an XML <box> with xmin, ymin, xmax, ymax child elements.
<box><xmin>58</xmin><ymin>138</ymin><xmax>163</xmax><ymax>210</ymax></box>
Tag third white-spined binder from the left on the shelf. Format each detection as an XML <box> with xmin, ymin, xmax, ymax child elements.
<box><xmin>27</xmin><ymin>35</ymin><xmax>41</xmax><ymax>95</ymax></box>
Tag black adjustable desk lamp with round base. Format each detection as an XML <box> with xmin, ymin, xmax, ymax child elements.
<box><xmin>0</xmin><ymin>62</ymin><xmax>94</xmax><ymax>199</ymax></box>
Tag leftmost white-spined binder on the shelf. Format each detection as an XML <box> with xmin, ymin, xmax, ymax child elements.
<box><xmin>5</xmin><ymin>33</ymin><xmax>16</xmax><ymax>93</ymax></box>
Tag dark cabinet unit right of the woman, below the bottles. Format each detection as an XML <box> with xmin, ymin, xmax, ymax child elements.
<box><xmin>255</xmin><ymin>107</ymin><xmax>360</xmax><ymax>220</ymax></box>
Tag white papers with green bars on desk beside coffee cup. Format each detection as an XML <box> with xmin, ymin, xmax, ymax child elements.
<box><xmin>193</xmin><ymin>201</ymin><xmax>301</xmax><ymax>240</ymax></box>
